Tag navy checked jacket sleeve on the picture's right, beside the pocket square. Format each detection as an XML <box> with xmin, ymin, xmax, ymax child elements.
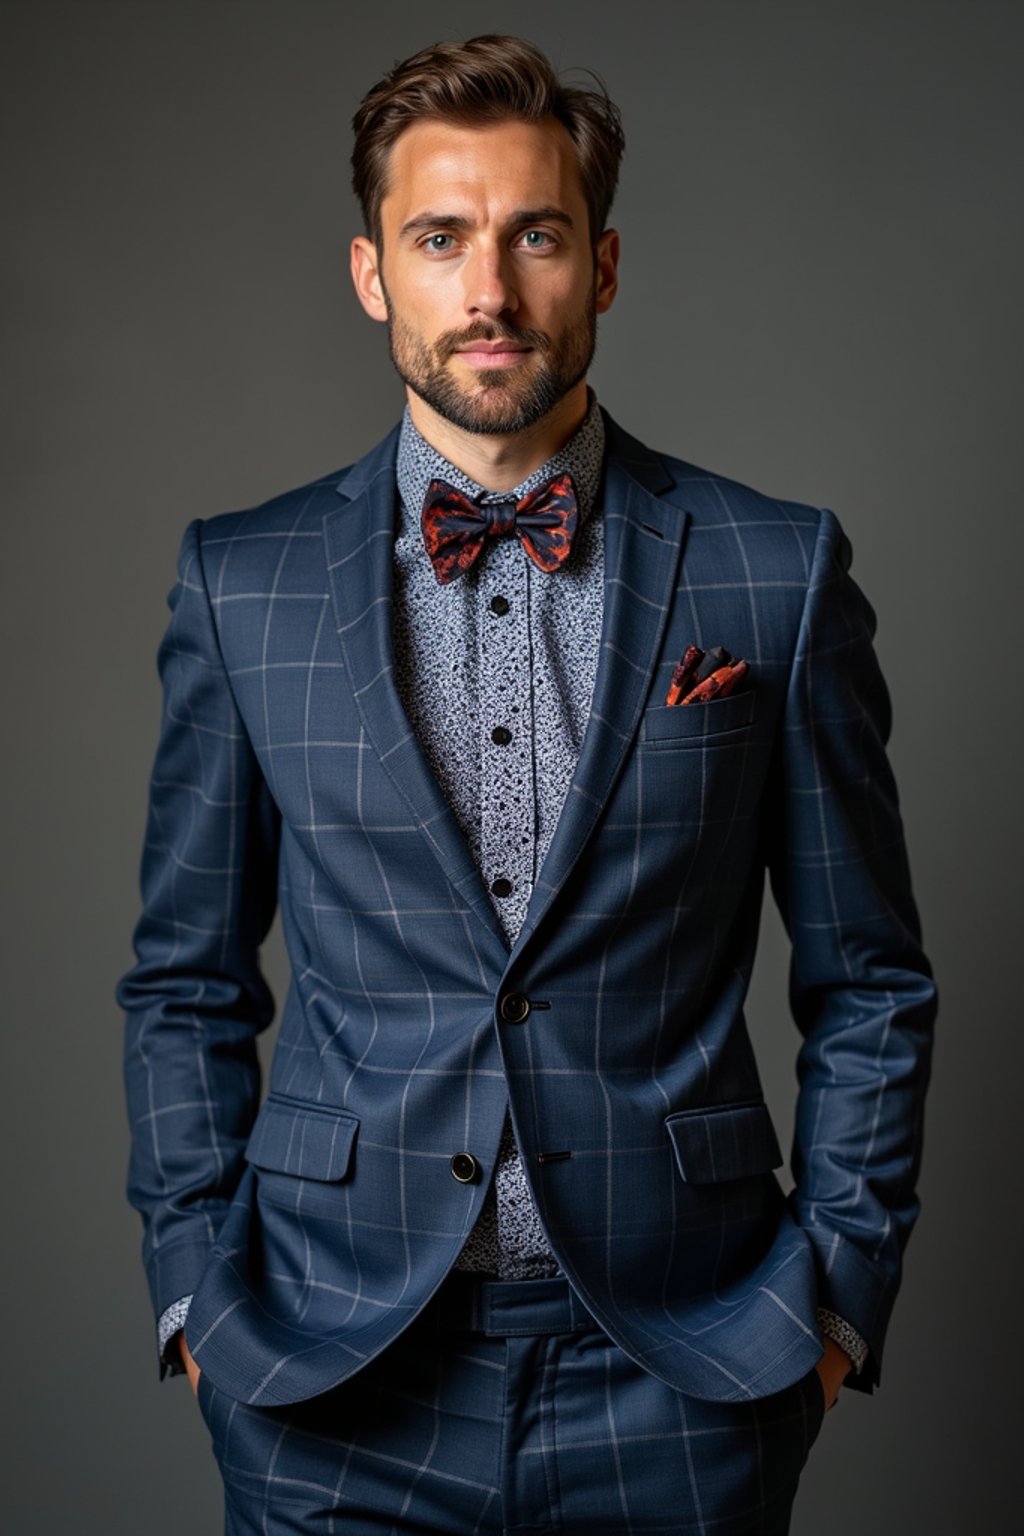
<box><xmin>769</xmin><ymin>511</ymin><xmax>936</xmax><ymax>1392</ymax></box>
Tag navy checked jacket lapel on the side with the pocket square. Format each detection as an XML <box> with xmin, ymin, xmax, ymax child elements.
<box><xmin>510</xmin><ymin>413</ymin><xmax>689</xmax><ymax>960</ymax></box>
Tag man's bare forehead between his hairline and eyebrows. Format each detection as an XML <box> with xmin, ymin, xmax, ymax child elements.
<box><xmin>381</xmin><ymin>118</ymin><xmax>586</xmax><ymax>227</ymax></box>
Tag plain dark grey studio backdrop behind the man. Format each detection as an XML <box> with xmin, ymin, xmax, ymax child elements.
<box><xmin>0</xmin><ymin>0</ymin><xmax>1024</xmax><ymax>1536</ymax></box>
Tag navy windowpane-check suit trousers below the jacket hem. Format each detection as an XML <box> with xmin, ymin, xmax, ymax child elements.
<box><xmin>200</xmin><ymin>1272</ymin><xmax>824</xmax><ymax>1536</ymax></box>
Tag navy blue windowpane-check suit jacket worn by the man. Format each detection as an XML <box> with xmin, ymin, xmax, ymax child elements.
<box><xmin>120</xmin><ymin>405</ymin><xmax>935</xmax><ymax>1404</ymax></box>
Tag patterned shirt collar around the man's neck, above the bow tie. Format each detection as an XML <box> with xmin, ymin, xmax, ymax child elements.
<box><xmin>395</xmin><ymin>390</ymin><xmax>605</xmax><ymax>527</ymax></box>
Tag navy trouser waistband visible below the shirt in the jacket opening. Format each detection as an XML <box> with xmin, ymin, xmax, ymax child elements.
<box><xmin>434</xmin><ymin>1270</ymin><xmax>597</xmax><ymax>1336</ymax></box>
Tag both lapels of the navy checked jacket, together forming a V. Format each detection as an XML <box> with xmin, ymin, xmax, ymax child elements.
<box><xmin>324</xmin><ymin>416</ymin><xmax>688</xmax><ymax>969</ymax></box>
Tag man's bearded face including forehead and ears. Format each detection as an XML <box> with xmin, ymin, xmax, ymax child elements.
<box><xmin>353</xmin><ymin>120</ymin><xmax>617</xmax><ymax>435</ymax></box>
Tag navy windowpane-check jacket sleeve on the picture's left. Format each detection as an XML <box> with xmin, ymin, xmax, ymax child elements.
<box><xmin>117</xmin><ymin>522</ymin><xmax>279</xmax><ymax>1357</ymax></box>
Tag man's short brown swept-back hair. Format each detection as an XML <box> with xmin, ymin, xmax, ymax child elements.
<box><xmin>352</xmin><ymin>32</ymin><xmax>625</xmax><ymax>249</ymax></box>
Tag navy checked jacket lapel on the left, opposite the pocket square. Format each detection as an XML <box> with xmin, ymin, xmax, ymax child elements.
<box><xmin>324</xmin><ymin>427</ymin><xmax>508</xmax><ymax>968</ymax></box>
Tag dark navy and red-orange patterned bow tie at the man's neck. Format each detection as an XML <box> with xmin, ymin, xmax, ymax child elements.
<box><xmin>421</xmin><ymin>475</ymin><xmax>579</xmax><ymax>585</ymax></box>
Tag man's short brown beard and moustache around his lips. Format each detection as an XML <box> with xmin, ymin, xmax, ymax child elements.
<box><xmin>384</xmin><ymin>290</ymin><xmax>597</xmax><ymax>436</ymax></box>
